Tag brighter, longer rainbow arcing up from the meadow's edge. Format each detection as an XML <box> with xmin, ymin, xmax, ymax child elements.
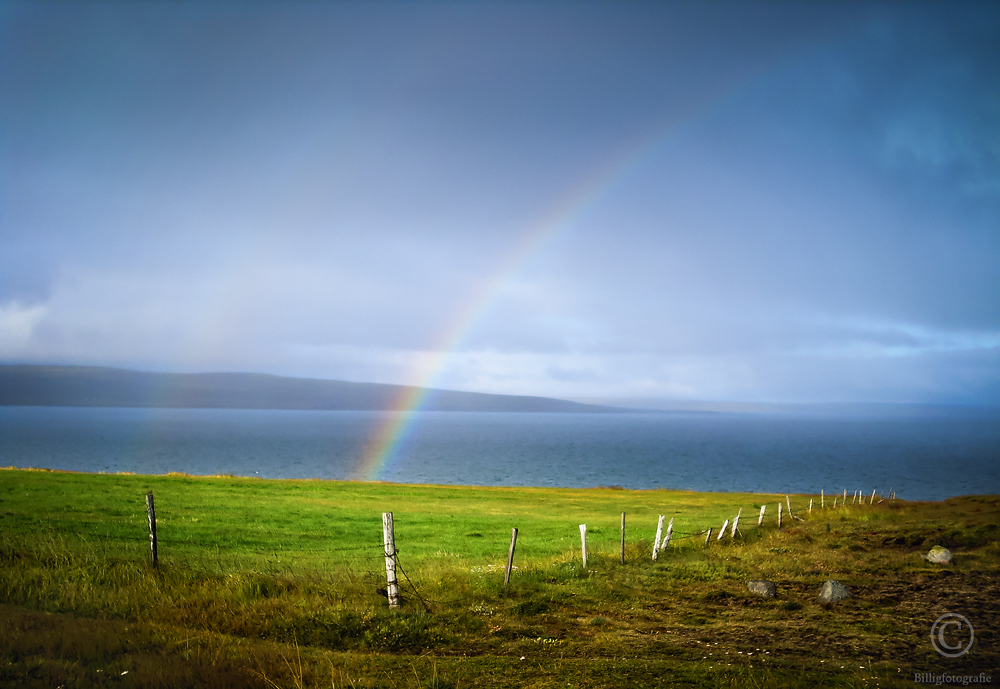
<box><xmin>354</xmin><ymin>69</ymin><xmax>764</xmax><ymax>481</ymax></box>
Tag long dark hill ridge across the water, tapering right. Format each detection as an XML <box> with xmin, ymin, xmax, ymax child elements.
<box><xmin>0</xmin><ymin>365</ymin><xmax>622</xmax><ymax>412</ymax></box>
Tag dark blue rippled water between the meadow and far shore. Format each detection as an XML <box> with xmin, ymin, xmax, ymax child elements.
<box><xmin>0</xmin><ymin>407</ymin><xmax>1000</xmax><ymax>500</ymax></box>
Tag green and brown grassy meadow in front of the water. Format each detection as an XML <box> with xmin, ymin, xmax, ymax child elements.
<box><xmin>0</xmin><ymin>469</ymin><xmax>1000</xmax><ymax>688</ymax></box>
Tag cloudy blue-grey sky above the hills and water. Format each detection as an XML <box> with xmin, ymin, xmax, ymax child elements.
<box><xmin>0</xmin><ymin>1</ymin><xmax>1000</xmax><ymax>406</ymax></box>
